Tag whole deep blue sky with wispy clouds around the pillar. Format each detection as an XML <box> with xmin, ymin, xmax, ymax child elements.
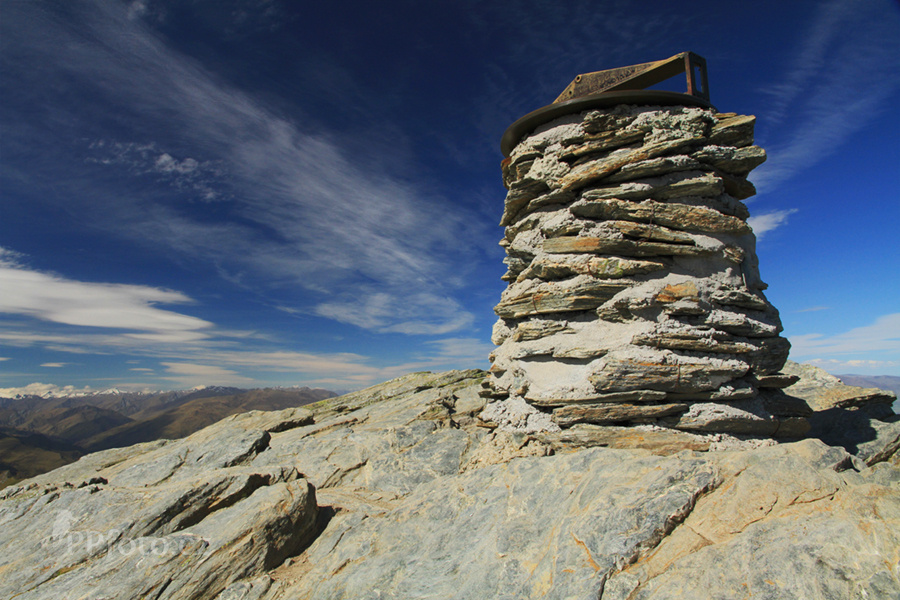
<box><xmin>0</xmin><ymin>0</ymin><xmax>900</xmax><ymax>394</ymax></box>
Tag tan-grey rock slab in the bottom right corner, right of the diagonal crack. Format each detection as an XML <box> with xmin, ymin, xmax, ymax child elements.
<box><xmin>602</xmin><ymin>441</ymin><xmax>900</xmax><ymax>600</ymax></box>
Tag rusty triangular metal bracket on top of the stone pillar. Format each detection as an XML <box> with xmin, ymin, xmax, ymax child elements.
<box><xmin>553</xmin><ymin>52</ymin><xmax>709</xmax><ymax>104</ymax></box>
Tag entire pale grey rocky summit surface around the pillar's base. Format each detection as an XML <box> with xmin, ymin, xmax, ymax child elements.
<box><xmin>0</xmin><ymin>366</ymin><xmax>900</xmax><ymax>600</ymax></box>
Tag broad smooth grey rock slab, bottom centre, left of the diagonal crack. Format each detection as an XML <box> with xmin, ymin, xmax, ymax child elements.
<box><xmin>288</xmin><ymin>450</ymin><xmax>718</xmax><ymax>599</ymax></box>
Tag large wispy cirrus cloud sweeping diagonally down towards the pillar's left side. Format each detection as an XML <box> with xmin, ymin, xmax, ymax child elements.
<box><xmin>4</xmin><ymin>1</ymin><xmax>486</xmax><ymax>333</ymax></box>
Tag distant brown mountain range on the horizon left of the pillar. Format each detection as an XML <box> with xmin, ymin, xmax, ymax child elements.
<box><xmin>0</xmin><ymin>386</ymin><xmax>337</xmax><ymax>488</ymax></box>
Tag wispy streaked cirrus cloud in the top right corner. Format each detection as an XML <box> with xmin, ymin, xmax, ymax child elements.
<box><xmin>754</xmin><ymin>0</ymin><xmax>900</xmax><ymax>192</ymax></box>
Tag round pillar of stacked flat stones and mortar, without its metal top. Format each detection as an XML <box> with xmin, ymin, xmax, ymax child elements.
<box><xmin>484</xmin><ymin>106</ymin><xmax>808</xmax><ymax>437</ymax></box>
